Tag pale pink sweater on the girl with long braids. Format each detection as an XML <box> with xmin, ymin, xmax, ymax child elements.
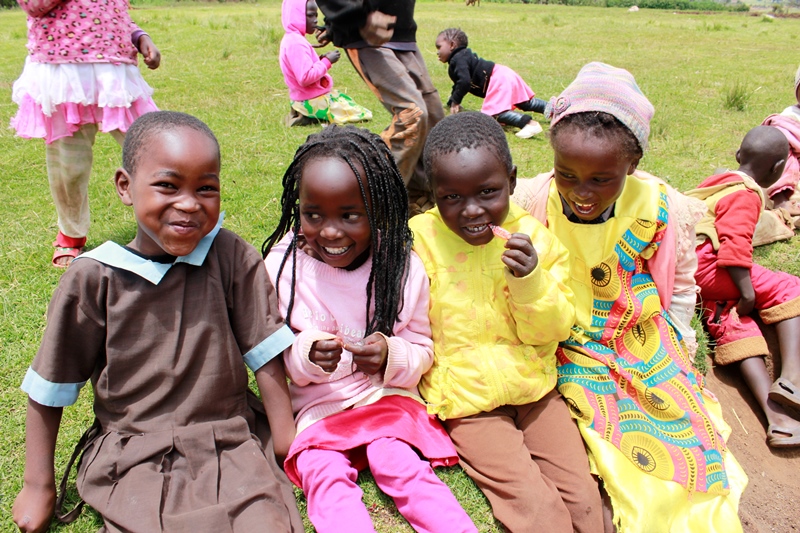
<box><xmin>264</xmin><ymin>234</ymin><xmax>433</xmax><ymax>433</ymax></box>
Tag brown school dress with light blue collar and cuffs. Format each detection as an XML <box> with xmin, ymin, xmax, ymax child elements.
<box><xmin>23</xmin><ymin>225</ymin><xmax>303</xmax><ymax>533</ymax></box>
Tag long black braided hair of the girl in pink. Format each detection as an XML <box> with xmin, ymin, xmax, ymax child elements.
<box><xmin>261</xmin><ymin>126</ymin><xmax>413</xmax><ymax>336</ymax></box>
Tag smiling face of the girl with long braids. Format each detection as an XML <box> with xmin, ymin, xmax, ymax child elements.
<box><xmin>299</xmin><ymin>157</ymin><xmax>372</xmax><ymax>268</ymax></box>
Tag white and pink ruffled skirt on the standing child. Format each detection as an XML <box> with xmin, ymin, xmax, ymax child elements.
<box><xmin>11</xmin><ymin>58</ymin><xmax>158</xmax><ymax>144</ymax></box>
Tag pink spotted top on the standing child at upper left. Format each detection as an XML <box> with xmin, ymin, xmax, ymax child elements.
<box><xmin>17</xmin><ymin>0</ymin><xmax>143</xmax><ymax>65</ymax></box>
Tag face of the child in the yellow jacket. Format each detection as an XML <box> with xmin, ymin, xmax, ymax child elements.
<box><xmin>431</xmin><ymin>148</ymin><xmax>517</xmax><ymax>246</ymax></box>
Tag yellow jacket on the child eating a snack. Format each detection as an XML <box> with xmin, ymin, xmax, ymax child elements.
<box><xmin>409</xmin><ymin>204</ymin><xmax>575</xmax><ymax>420</ymax></box>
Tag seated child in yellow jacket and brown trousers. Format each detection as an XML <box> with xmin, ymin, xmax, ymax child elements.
<box><xmin>410</xmin><ymin>112</ymin><xmax>603</xmax><ymax>533</ymax></box>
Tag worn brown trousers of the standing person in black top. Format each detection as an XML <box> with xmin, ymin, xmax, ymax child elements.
<box><xmin>347</xmin><ymin>47</ymin><xmax>444</xmax><ymax>207</ymax></box>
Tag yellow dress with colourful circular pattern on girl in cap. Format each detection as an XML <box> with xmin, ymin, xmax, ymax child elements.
<box><xmin>547</xmin><ymin>178</ymin><xmax>747</xmax><ymax>533</ymax></box>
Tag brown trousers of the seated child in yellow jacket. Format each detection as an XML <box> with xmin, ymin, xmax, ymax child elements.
<box><xmin>444</xmin><ymin>390</ymin><xmax>603</xmax><ymax>533</ymax></box>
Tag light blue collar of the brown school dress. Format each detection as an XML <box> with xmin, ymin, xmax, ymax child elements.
<box><xmin>75</xmin><ymin>212</ymin><xmax>225</xmax><ymax>285</ymax></box>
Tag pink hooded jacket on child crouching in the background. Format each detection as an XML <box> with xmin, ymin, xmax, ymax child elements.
<box><xmin>278</xmin><ymin>0</ymin><xmax>333</xmax><ymax>102</ymax></box>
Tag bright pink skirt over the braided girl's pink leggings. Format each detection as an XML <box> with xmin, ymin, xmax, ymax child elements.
<box><xmin>283</xmin><ymin>396</ymin><xmax>458</xmax><ymax>487</ymax></box>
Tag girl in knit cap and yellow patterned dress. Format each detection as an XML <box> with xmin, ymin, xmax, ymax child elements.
<box><xmin>515</xmin><ymin>63</ymin><xmax>747</xmax><ymax>533</ymax></box>
